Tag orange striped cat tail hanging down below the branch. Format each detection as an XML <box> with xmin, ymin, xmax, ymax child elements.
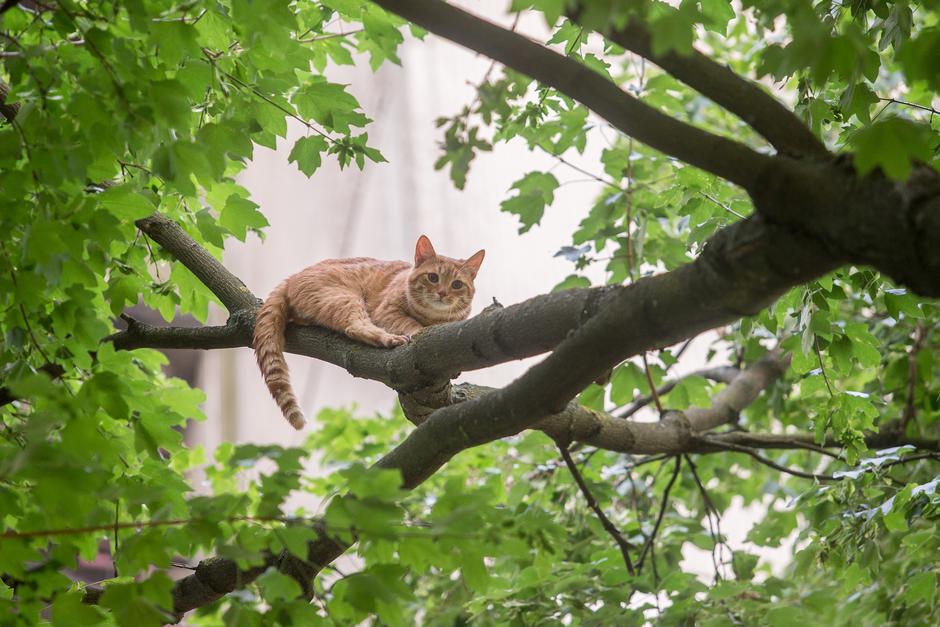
<box><xmin>253</xmin><ymin>281</ymin><xmax>305</xmax><ymax>429</ymax></box>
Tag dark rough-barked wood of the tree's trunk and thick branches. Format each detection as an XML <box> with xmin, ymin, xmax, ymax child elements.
<box><xmin>0</xmin><ymin>0</ymin><xmax>940</xmax><ymax>616</ymax></box>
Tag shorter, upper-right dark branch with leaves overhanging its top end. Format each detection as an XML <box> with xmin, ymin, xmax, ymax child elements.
<box><xmin>572</xmin><ymin>13</ymin><xmax>829</xmax><ymax>157</ymax></box>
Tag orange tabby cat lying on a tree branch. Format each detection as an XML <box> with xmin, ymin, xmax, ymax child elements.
<box><xmin>254</xmin><ymin>235</ymin><xmax>485</xmax><ymax>429</ymax></box>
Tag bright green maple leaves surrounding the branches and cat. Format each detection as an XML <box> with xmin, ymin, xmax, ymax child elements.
<box><xmin>0</xmin><ymin>0</ymin><xmax>940</xmax><ymax>627</ymax></box>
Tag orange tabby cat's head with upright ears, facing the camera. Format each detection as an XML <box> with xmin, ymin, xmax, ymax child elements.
<box><xmin>408</xmin><ymin>235</ymin><xmax>486</xmax><ymax>324</ymax></box>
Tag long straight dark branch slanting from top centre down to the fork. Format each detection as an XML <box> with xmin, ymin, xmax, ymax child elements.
<box><xmin>374</xmin><ymin>0</ymin><xmax>770</xmax><ymax>190</ymax></box>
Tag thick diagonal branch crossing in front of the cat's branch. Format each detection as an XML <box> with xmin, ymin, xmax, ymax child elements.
<box><xmin>374</xmin><ymin>219</ymin><xmax>830</xmax><ymax>485</ymax></box>
